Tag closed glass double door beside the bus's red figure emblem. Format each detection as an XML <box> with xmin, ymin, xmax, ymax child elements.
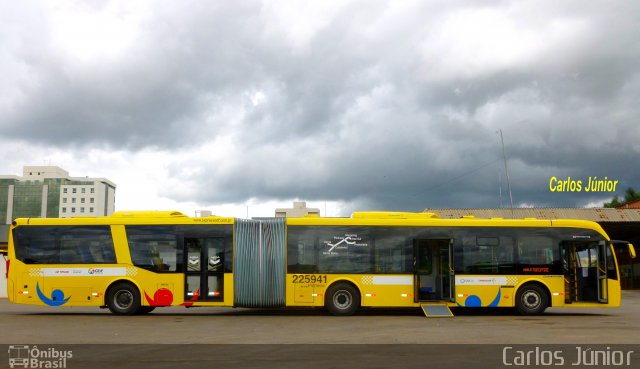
<box><xmin>184</xmin><ymin>237</ymin><xmax>224</xmax><ymax>301</ymax></box>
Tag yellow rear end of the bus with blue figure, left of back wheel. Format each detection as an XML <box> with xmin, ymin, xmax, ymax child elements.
<box><xmin>7</xmin><ymin>219</ymin><xmax>120</xmax><ymax>306</ymax></box>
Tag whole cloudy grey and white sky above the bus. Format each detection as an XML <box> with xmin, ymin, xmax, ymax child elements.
<box><xmin>0</xmin><ymin>0</ymin><xmax>640</xmax><ymax>217</ymax></box>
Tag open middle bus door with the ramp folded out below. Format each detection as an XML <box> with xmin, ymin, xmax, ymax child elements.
<box><xmin>413</xmin><ymin>239</ymin><xmax>455</xmax><ymax>302</ymax></box>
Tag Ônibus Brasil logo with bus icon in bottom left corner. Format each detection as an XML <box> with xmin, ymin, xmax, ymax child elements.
<box><xmin>9</xmin><ymin>345</ymin><xmax>73</xmax><ymax>368</ymax></box>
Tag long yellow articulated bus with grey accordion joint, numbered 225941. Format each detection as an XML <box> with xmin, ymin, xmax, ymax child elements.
<box><xmin>7</xmin><ymin>208</ymin><xmax>635</xmax><ymax>315</ymax></box>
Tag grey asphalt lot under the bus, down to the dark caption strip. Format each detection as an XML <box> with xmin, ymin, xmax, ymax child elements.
<box><xmin>0</xmin><ymin>291</ymin><xmax>640</xmax><ymax>344</ymax></box>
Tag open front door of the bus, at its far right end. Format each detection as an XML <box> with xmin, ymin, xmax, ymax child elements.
<box><xmin>560</xmin><ymin>241</ymin><xmax>610</xmax><ymax>304</ymax></box>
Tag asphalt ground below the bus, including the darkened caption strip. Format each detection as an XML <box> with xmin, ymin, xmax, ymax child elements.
<box><xmin>0</xmin><ymin>291</ymin><xmax>640</xmax><ymax>369</ymax></box>
